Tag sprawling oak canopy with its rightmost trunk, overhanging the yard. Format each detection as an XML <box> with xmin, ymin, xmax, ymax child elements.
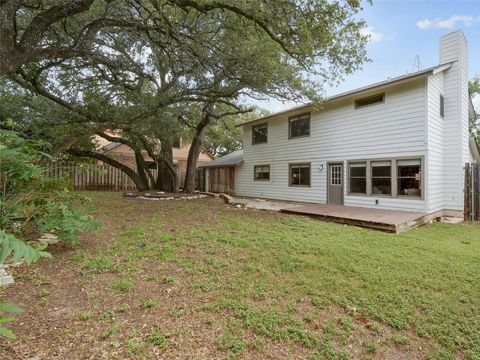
<box><xmin>0</xmin><ymin>0</ymin><xmax>372</xmax><ymax>191</ymax></box>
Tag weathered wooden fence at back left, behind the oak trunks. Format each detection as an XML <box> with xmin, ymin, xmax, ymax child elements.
<box><xmin>45</xmin><ymin>162</ymin><xmax>157</xmax><ymax>191</ymax></box>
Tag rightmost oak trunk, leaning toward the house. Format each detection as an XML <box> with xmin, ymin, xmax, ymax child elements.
<box><xmin>183</xmin><ymin>106</ymin><xmax>212</xmax><ymax>194</ymax></box>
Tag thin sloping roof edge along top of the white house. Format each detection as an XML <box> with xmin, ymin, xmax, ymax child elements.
<box><xmin>237</xmin><ymin>62</ymin><xmax>452</xmax><ymax>127</ymax></box>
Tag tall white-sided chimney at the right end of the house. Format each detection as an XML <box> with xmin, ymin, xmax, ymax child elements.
<box><xmin>440</xmin><ymin>31</ymin><xmax>469</xmax><ymax>210</ymax></box>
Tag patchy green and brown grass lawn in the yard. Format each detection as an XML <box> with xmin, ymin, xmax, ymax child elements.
<box><xmin>0</xmin><ymin>193</ymin><xmax>480</xmax><ymax>359</ymax></box>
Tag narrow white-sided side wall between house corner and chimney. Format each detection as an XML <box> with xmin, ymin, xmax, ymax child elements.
<box><xmin>427</xmin><ymin>72</ymin><xmax>444</xmax><ymax>213</ymax></box>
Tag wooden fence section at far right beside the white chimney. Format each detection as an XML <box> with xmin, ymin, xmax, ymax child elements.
<box><xmin>463</xmin><ymin>163</ymin><xmax>480</xmax><ymax>221</ymax></box>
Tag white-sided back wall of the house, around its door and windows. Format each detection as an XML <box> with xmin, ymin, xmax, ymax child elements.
<box><xmin>235</xmin><ymin>78</ymin><xmax>427</xmax><ymax>212</ymax></box>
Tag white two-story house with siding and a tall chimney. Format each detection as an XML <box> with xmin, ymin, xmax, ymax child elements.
<box><xmin>203</xmin><ymin>31</ymin><xmax>479</xmax><ymax>215</ymax></box>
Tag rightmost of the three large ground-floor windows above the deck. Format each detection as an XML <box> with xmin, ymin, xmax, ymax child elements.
<box><xmin>397</xmin><ymin>159</ymin><xmax>422</xmax><ymax>197</ymax></box>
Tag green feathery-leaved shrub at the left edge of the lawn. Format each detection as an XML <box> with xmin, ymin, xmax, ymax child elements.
<box><xmin>0</xmin><ymin>128</ymin><xmax>98</xmax><ymax>339</ymax></box>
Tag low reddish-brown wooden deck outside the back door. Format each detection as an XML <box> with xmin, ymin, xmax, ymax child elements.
<box><xmin>280</xmin><ymin>204</ymin><xmax>428</xmax><ymax>234</ymax></box>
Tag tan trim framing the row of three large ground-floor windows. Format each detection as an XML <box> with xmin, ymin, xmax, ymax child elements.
<box><xmin>346</xmin><ymin>155</ymin><xmax>426</xmax><ymax>201</ymax></box>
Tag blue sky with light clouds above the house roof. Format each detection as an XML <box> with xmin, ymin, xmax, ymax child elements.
<box><xmin>256</xmin><ymin>0</ymin><xmax>480</xmax><ymax>112</ymax></box>
